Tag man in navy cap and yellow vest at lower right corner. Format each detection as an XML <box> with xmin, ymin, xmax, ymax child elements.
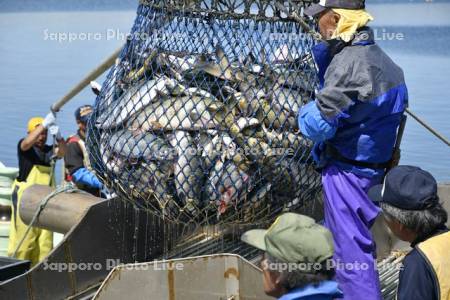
<box><xmin>369</xmin><ymin>166</ymin><xmax>450</xmax><ymax>300</ymax></box>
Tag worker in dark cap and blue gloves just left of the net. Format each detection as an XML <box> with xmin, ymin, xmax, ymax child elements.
<box><xmin>64</xmin><ymin>105</ymin><xmax>102</xmax><ymax>196</ymax></box>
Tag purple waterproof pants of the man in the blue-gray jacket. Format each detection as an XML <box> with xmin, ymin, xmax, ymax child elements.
<box><xmin>322</xmin><ymin>165</ymin><xmax>381</xmax><ymax>300</ymax></box>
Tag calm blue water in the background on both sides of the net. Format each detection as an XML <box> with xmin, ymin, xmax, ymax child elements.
<box><xmin>0</xmin><ymin>3</ymin><xmax>450</xmax><ymax>182</ymax></box>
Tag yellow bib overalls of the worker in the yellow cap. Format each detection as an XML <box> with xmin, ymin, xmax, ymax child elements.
<box><xmin>8</xmin><ymin>165</ymin><xmax>54</xmax><ymax>266</ymax></box>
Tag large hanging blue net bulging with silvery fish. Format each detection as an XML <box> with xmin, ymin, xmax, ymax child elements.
<box><xmin>87</xmin><ymin>0</ymin><xmax>320</xmax><ymax>230</ymax></box>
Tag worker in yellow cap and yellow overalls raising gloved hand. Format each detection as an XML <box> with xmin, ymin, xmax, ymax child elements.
<box><xmin>8</xmin><ymin>113</ymin><xmax>65</xmax><ymax>266</ymax></box>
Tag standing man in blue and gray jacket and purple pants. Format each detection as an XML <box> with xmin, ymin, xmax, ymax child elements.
<box><xmin>299</xmin><ymin>0</ymin><xmax>408</xmax><ymax>300</ymax></box>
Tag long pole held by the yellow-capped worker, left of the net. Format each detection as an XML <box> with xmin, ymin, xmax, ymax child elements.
<box><xmin>51</xmin><ymin>47</ymin><xmax>122</xmax><ymax>112</ymax></box>
